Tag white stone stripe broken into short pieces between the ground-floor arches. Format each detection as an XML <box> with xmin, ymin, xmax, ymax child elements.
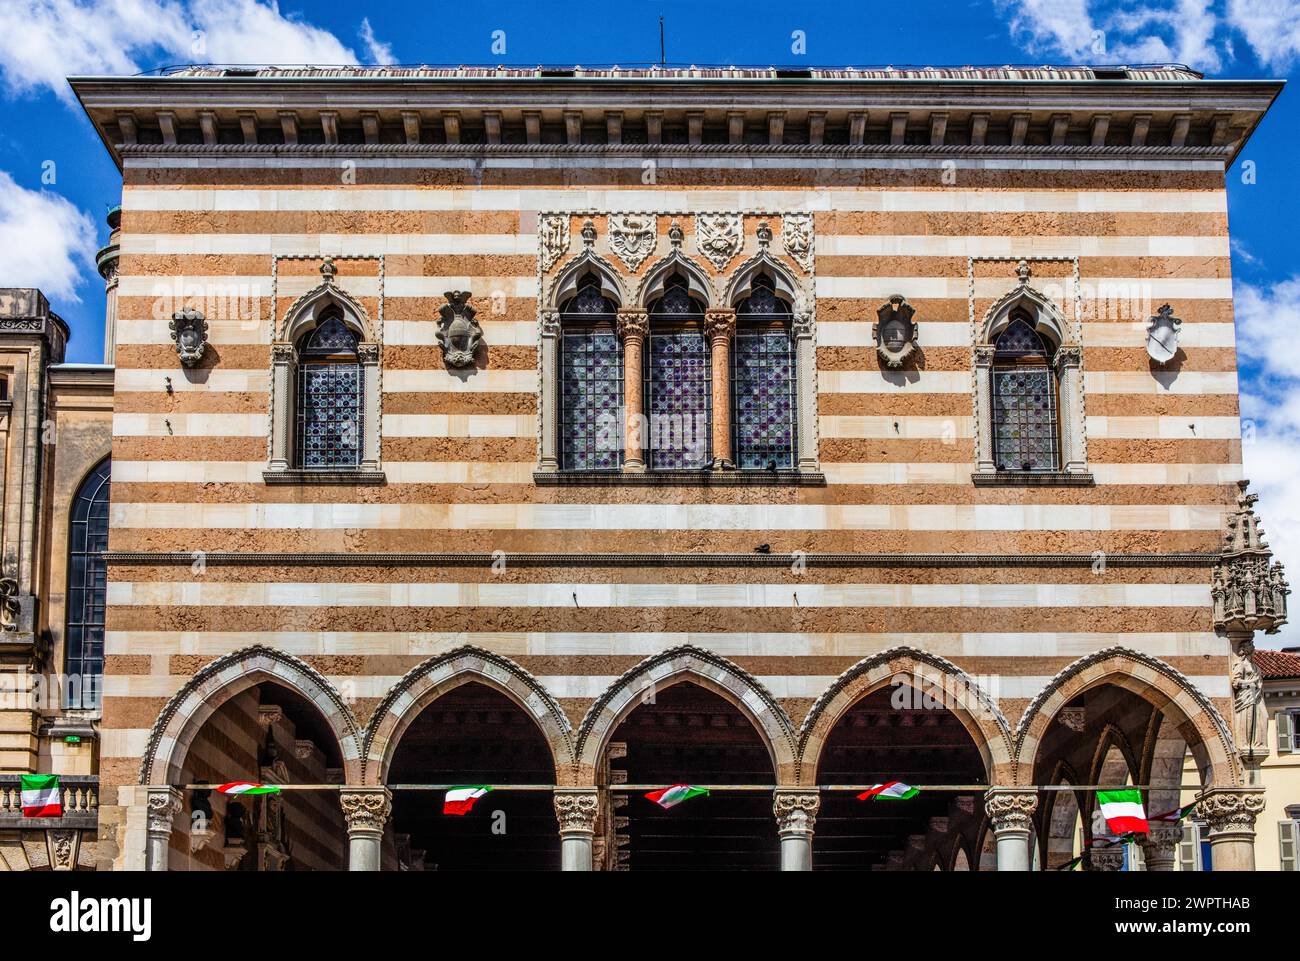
<box><xmin>96</xmin><ymin>674</ymin><xmax>1230</xmax><ymax>702</ymax></box>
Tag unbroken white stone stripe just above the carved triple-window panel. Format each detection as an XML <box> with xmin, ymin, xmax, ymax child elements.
<box><xmin>122</xmin><ymin>185</ymin><xmax>1227</xmax><ymax>211</ymax></box>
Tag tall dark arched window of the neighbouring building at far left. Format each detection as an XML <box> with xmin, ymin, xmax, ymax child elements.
<box><xmin>64</xmin><ymin>458</ymin><xmax>111</xmax><ymax>707</ymax></box>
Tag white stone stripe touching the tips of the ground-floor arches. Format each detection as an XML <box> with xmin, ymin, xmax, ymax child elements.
<box><xmin>104</xmin><ymin>629</ymin><xmax>1225</xmax><ymax>657</ymax></box>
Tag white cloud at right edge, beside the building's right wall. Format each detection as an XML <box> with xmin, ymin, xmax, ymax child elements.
<box><xmin>1235</xmin><ymin>277</ymin><xmax>1300</xmax><ymax>646</ymax></box>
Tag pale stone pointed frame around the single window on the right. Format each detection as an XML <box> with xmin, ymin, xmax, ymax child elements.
<box><xmin>972</xmin><ymin>282</ymin><xmax>1092</xmax><ymax>485</ymax></box>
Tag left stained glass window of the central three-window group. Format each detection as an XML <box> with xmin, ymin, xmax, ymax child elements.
<box><xmin>559</xmin><ymin>281</ymin><xmax>623</xmax><ymax>471</ymax></box>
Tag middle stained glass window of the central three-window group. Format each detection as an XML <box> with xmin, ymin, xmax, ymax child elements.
<box><xmin>646</xmin><ymin>277</ymin><xmax>712</xmax><ymax>471</ymax></box>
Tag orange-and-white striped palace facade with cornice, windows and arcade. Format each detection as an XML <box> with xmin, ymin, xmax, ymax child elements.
<box><xmin>5</xmin><ymin>68</ymin><xmax>1287</xmax><ymax>870</ymax></box>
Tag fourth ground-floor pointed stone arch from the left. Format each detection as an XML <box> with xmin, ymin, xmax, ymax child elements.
<box><xmin>800</xmin><ymin>646</ymin><xmax>1011</xmax><ymax>784</ymax></box>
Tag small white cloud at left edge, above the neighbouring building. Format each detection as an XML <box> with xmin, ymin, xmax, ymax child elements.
<box><xmin>0</xmin><ymin>170</ymin><xmax>99</xmax><ymax>300</ymax></box>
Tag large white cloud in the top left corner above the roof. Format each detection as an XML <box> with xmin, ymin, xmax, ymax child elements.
<box><xmin>0</xmin><ymin>0</ymin><xmax>393</xmax><ymax>99</ymax></box>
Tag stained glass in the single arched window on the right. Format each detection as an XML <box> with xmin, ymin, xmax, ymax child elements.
<box><xmin>993</xmin><ymin>317</ymin><xmax>1060</xmax><ymax>471</ymax></box>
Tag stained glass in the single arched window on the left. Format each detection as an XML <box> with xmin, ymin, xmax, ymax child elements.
<box><xmin>296</xmin><ymin>315</ymin><xmax>363</xmax><ymax>469</ymax></box>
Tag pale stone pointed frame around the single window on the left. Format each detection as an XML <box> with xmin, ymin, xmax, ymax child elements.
<box><xmin>263</xmin><ymin>270</ymin><xmax>384</xmax><ymax>484</ymax></box>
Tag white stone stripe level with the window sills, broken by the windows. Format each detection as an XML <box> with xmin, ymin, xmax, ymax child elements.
<box><xmin>113</xmin><ymin>460</ymin><xmax>1243</xmax><ymax>486</ymax></box>
